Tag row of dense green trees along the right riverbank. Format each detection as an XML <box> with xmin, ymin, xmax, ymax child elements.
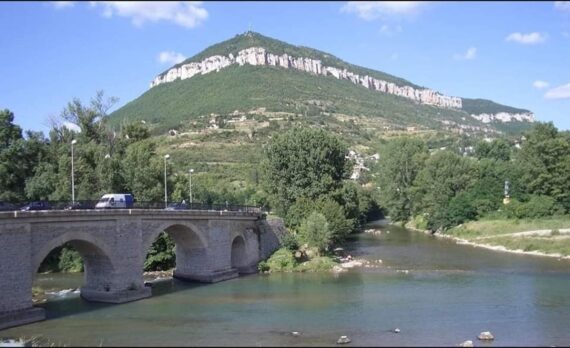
<box><xmin>376</xmin><ymin>123</ymin><xmax>570</xmax><ymax>231</ymax></box>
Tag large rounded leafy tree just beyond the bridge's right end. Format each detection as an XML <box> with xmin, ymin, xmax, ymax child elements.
<box><xmin>263</xmin><ymin>128</ymin><xmax>350</xmax><ymax>215</ymax></box>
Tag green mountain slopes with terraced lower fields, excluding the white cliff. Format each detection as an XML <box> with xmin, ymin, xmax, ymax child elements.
<box><xmin>108</xmin><ymin>32</ymin><xmax>531</xmax><ymax>187</ymax></box>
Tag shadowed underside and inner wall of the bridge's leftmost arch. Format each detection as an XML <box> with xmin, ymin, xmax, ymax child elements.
<box><xmin>32</xmin><ymin>232</ymin><xmax>115</xmax><ymax>291</ymax></box>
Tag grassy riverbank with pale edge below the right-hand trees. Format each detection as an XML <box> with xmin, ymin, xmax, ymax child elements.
<box><xmin>405</xmin><ymin>216</ymin><xmax>570</xmax><ymax>259</ymax></box>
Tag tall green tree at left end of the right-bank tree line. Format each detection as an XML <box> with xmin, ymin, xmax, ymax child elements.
<box><xmin>372</xmin><ymin>137</ymin><xmax>428</xmax><ymax>221</ymax></box>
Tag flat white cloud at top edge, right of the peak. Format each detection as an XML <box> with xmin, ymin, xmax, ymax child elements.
<box><xmin>340</xmin><ymin>1</ymin><xmax>425</xmax><ymax>21</ymax></box>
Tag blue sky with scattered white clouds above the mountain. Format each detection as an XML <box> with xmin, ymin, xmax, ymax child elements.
<box><xmin>0</xmin><ymin>1</ymin><xmax>570</xmax><ymax>134</ymax></box>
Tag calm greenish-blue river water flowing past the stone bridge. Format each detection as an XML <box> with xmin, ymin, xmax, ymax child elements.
<box><xmin>0</xmin><ymin>222</ymin><xmax>570</xmax><ymax>346</ymax></box>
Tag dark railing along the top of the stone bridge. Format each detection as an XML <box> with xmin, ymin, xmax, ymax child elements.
<box><xmin>0</xmin><ymin>201</ymin><xmax>266</xmax><ymax>214</ymax></box>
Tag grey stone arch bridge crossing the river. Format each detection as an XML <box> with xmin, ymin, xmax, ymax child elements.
<box><xmin>0</xmin><ymin>209</ymin><xmax>283</xmax><ymax>330</ymax></box>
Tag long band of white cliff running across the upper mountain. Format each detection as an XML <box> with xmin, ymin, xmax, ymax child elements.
<box><xmin>150</xmin><ymin>47</ymin><xmax>462</xmax><ymax>109</ymax></box>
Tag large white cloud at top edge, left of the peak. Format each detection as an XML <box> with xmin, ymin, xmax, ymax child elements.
<box><xmin>90</xmin><ymin>1</ymin><xmax>208</xmax><ymax>28</ymax></box>
